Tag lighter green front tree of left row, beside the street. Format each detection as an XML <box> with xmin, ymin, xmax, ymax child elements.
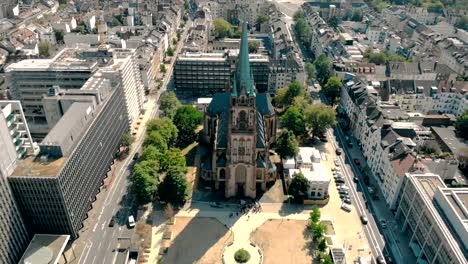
<box><xmin>131</xmin><ymin>161</ymin><xmax>158</xmax><ymax>204</ymax></box>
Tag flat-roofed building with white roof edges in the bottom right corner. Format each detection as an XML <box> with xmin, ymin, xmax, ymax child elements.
<box><xmin>396</xmin><ymin>173</ymin><xmax>468</xmax><ymax>264</ymax></box>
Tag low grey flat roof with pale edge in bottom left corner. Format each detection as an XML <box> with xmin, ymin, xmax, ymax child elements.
<box><xmin>18</xmin><ymin>234</ymin><xmax>70</xmax><ymax>264</ymax></box>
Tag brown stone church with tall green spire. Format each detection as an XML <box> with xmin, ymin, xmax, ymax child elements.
<box><xmin>201</xmin><ymin>22</ymin><xmax>277</xmax><ymax>198</ymax></box>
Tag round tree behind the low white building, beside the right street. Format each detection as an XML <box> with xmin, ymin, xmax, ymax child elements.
<box><xmin>304</xmin><ymin>104</ymin><xmax>336</xmax><ymax>136</ymax></box>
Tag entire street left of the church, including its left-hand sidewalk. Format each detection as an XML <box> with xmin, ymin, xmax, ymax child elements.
<box><xmin>60</xmin><ymin>18</ymin><xmax>190</xmax><ymax>264</ymax></box>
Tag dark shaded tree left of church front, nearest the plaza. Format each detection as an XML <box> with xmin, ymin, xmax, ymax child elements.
<box><xmin>158</xmin><ymin>169</ymin><xmax>188</xmax><ymax>206</ymax></box>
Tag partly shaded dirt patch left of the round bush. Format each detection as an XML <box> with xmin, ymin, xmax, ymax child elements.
<box><xmin>163</xmin><ymin>217</ymin><xmax>233</xmax><ymax>264</ymax></box>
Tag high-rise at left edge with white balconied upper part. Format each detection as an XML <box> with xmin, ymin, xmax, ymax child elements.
<box><xmin>0</xmin><ymin>101</ymin><xmax>32</xmax><ymax>264</ymax></box>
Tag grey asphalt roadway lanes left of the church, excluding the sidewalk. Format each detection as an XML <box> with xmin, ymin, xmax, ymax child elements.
<box><xmin>78</xmin><ymin>19</ymin><xmax>190</xmax><ymax>264</ymax></box>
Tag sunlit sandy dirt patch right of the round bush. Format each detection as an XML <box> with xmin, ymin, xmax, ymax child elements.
<box><xmin>251</xmin><ymin>219</ymin><xmax>314</xmax><ymax>264</ymax></box>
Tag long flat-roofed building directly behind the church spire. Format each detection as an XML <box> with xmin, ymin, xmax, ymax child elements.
<box><xmin>174</xmin><ymin>50</ymin><xmax>270</xmax><ymax>98</ymax></box>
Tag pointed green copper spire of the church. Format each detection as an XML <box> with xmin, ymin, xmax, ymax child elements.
<box><xmin>232</xmin><ymin>21</ymin><xmax>255</xmax><ymax>96</ymax></box>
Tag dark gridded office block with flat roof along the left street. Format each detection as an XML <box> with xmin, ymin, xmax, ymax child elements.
<box><xmin>8</xmin><ymin>77</ymin><xmax>128</xmax><ymax>238</ymax></box>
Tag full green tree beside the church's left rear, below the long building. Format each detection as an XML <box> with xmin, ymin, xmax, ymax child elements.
<box><xmin>174</xmin><ymin>105</ymin><xmax>203</xmax><ymax>146</ymax></box>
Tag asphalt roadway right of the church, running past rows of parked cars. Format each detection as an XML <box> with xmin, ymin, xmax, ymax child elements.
<box><xmin>327</xmin><ymin>129</ymin><xmax>385</xmax><ymax>258</ymax></box>
